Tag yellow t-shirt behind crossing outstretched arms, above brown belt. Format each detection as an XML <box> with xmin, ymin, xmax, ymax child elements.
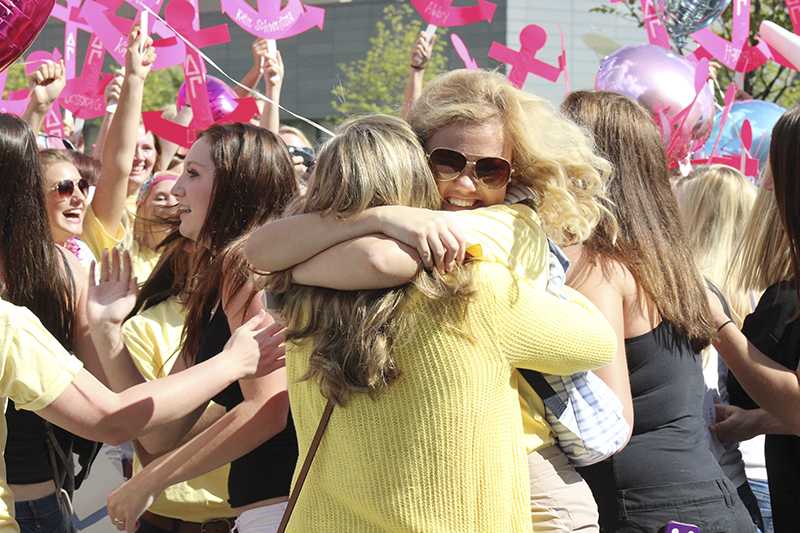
<box><xmin>122</xmin><ymin>298</ymin><xmax>236</xmax><ymax>522</ymax></box>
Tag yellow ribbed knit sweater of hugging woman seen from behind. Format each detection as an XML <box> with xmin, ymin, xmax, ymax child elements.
<box><xmin>286</xmin><ymin>206</ymin><xmax>616</xmax><ymax>533</ymax></box>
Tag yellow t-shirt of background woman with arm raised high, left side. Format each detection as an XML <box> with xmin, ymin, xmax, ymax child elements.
<box><xmin>81</xmin><ymin>199</ymin><xmax>161</xmax><ymax>283</ymax></box>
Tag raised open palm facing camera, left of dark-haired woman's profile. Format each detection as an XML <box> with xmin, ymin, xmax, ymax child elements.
<box><xmin>86</xmin><ymin>248</ymin><xmax>138</xmax><ymax>327</ymax></box>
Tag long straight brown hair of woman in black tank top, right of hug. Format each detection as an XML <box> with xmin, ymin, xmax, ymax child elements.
<box><xmin>562</xmin><ymin>91</ymin><xmax>713</xmax><ymax>351</ymax></box>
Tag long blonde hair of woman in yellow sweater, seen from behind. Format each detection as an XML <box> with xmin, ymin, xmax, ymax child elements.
<box><xmin>266</xmin><ymin>115</ymin><xmax>473</xmax><ymax>404</ymax></box>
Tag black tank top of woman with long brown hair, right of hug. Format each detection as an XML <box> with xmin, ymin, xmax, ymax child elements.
<box><xmin>580</xmin><ymin>321</ymin><xmax>724</xmax><ymax>525</ymax></box>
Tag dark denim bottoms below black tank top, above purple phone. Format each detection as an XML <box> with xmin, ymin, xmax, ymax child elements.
<box><xmin>616</xmin><ymin>479</ymin><xmax>755</xmax><ymax>533</ymax></box>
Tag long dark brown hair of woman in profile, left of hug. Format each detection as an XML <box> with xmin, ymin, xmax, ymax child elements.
<box><xmin>181</xmin><ymin>124</ymin><xmax>297</xmax><ymax>362</ymax></box>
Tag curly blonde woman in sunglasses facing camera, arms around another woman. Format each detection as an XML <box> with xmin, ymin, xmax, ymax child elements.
<box><xmin>247</xmin><ymin>70</ymin><xmax>632</xmax><ymax>531</ymax></box>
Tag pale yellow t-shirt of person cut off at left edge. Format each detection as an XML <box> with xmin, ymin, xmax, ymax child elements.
<box><xmin>0</xmin><ymin>299</ymin><xmax>83</xmax><ymax>533</ymax></box>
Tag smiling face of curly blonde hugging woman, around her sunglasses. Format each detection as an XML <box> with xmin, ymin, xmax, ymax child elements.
<box><xmin>425</xmin><ymin>119</ymin><xmax>512</xmax><ymax>211</ymax></box>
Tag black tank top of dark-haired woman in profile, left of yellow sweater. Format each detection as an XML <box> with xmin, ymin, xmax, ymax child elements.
<box><xmin>197</xmin><ymin>306</ymin><xmax>297</xmax><ymax>507</ymax></box>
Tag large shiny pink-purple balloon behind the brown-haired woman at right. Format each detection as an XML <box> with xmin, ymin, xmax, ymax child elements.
<box><xmin>595</xmin><ymin>44</ymin><xmax>715</xmax><ymax>162</ymax></box>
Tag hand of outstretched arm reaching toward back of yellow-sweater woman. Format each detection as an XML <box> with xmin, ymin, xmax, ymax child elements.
<box><xmin>219</xmin><ymin>310</ymin><xmax>286</xmax><ymax>378</ymax></box>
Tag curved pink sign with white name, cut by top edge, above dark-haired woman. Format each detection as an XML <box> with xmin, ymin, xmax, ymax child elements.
<box><xmin>220</xmin><ymin>0</ymin><xmax>325</xmax><ymax>40</ymax></box>
